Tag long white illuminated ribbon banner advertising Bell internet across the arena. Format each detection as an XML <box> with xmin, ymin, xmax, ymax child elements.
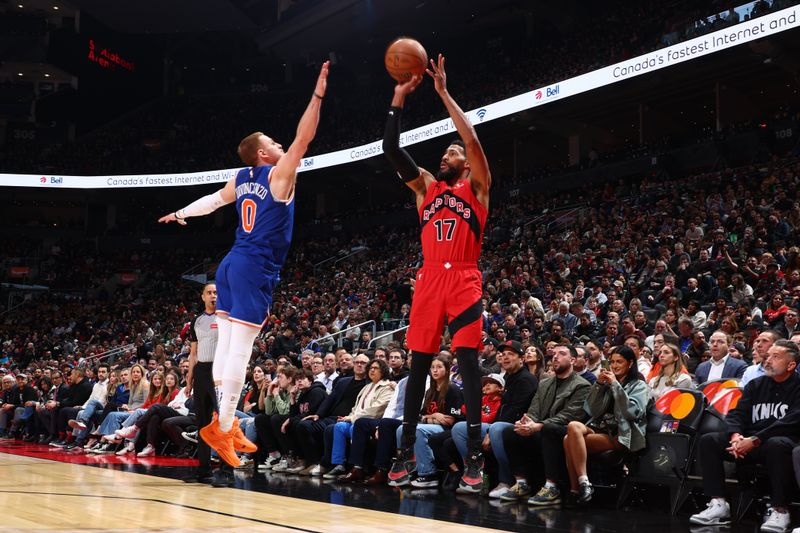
<box><xmin>0</xmin><ymin>6</ymin><xmax>800</xmax><ymax>189</ymax></box>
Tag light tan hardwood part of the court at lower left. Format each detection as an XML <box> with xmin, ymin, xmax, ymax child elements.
<box><xmin>0</xmin><ymin>453</ymin><xmax>510</xmax><ymax>533</ymax></box>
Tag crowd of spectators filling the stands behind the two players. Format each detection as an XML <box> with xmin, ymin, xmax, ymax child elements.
<box><xmin>0</xmin><ymin>135</ymin><xmax>800</xmax><ymax>531</ymax></box>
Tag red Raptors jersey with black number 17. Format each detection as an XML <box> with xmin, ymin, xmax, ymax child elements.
<box><xmin>419</xmin><ymin>179</ymin><xmax>488</xmax><ymax>264</ymax></box>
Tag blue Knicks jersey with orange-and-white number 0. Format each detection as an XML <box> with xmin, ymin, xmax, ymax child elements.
<box><xmin>231</xmin><ymin>165</ymin><xmax>294</xmax><ymax>274</ymax></box>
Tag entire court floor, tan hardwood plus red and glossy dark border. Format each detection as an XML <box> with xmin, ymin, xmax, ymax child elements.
<box><xmin>0</xmin><ymin>441</ymin><xmax>776</xmax><ymax>533</ymax></box>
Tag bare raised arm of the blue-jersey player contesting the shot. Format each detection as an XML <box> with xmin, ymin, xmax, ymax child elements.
<box><xmin>270</xmin><ymin>61</ymin><xmax>330</xmax><ymax>198</ymax></box>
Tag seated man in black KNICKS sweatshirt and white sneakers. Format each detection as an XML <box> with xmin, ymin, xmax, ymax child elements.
<box><xmin>690</xmin><ymin>340</ymin><xmax>800</xmax><ymax>533</ymax></box>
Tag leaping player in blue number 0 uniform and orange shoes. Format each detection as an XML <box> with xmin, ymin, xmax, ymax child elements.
<box><xmin>158</xmin><ymin>61</ymin><xmax>329</xmax><ymax>466</ymax></box>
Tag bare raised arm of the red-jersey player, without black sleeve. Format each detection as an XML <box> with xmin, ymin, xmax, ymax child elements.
<box><xmin>425</xmin><ymin>54</ymin><xmax>492</xmax><ymax>198</ymax></box>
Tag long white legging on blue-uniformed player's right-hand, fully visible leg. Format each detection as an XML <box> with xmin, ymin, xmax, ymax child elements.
<box><xmin>219</xmin><ymin>323</ymin><xmax>260</xmax><ymax>431</ymax></box>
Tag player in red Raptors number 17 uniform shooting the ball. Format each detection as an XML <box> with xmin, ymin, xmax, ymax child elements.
<box><xmin>383</xmin><ymin>54</ymin><xmax>492</xmax><ymax>492</ymax></box>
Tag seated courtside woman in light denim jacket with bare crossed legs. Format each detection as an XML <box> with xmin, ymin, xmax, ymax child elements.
<box><xmin>564</xmin><ymin>346</ymin><xmax>650</xmax><ymax>503</ymax></box>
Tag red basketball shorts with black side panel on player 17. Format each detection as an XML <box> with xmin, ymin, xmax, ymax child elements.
<box><xmin>406</xmin><ymin>263</ymin><xmax>483</xmax><ymax>353</ymax></box>
